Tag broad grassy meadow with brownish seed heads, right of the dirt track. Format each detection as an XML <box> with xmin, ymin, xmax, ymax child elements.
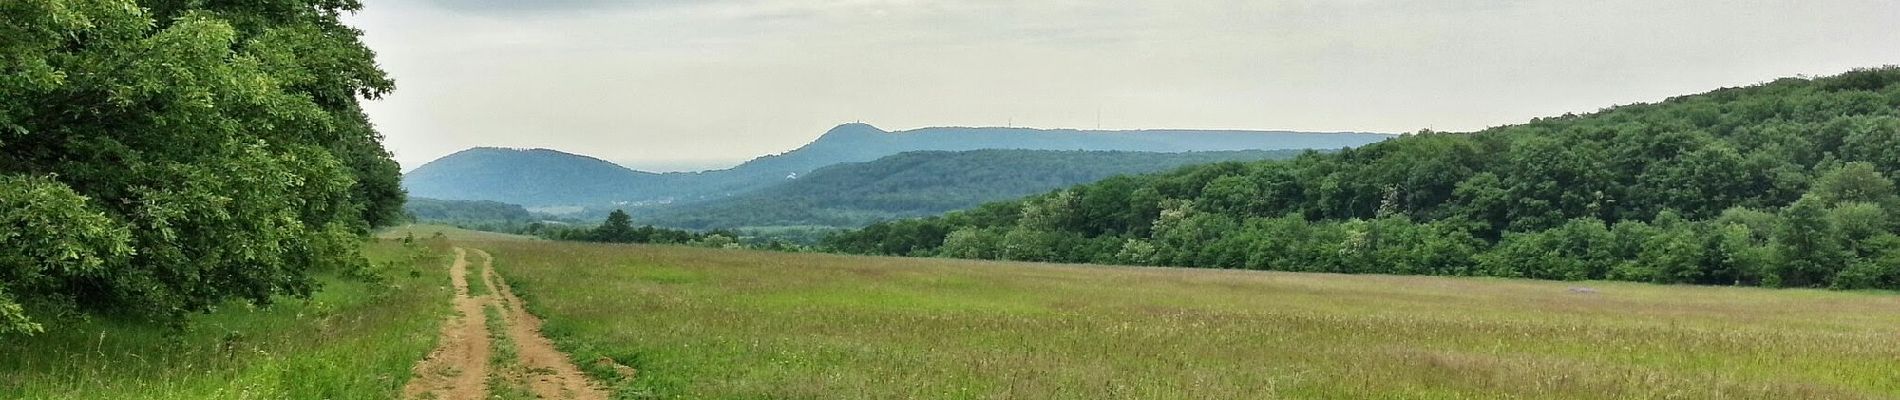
<box><xmin>477</xmin><ymin>241</ymin><xmax>1900</xmax><ymax>398</ymax></box>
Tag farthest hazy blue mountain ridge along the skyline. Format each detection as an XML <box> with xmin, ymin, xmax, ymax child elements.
<box><xmin>403</xmin><ymin>123</ymin><xmax>1393</xmax><ymax>207</ymax></box>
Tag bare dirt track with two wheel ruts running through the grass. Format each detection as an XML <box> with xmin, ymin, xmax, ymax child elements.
<box><xmin>403</xmin><ymin>248</ymin><xmax>606</xmax><ymax>400</ymax></box>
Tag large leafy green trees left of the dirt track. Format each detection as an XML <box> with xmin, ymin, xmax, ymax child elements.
<box><xmin>0</xmin><ymin>0</ymin><xmax>403</xmax><ymax>334</ymax></box>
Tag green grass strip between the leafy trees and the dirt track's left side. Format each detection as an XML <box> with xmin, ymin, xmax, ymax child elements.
<box><xmin>0</xmin><ymin>241</ymin><xmax>450</xmax><ymax>398</ymax></box>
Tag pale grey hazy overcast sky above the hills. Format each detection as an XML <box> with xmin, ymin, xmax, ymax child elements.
<box><xmin>350</xmin><ymin>0</ymin><xmax>1900</xmax><ymax>169</ymax></box>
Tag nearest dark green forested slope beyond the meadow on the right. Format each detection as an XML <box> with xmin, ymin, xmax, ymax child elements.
<box><xmin>827</xmin><ymin>66</ymin><xmax>1900</xmax><ymax>288</ymax></box>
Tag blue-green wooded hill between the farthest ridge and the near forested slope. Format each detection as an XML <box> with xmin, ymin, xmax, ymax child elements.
<box><xmin>637</xmin><ymin>150</ymin><xmax>1307</xmax><ymax>229</ymax></box>
